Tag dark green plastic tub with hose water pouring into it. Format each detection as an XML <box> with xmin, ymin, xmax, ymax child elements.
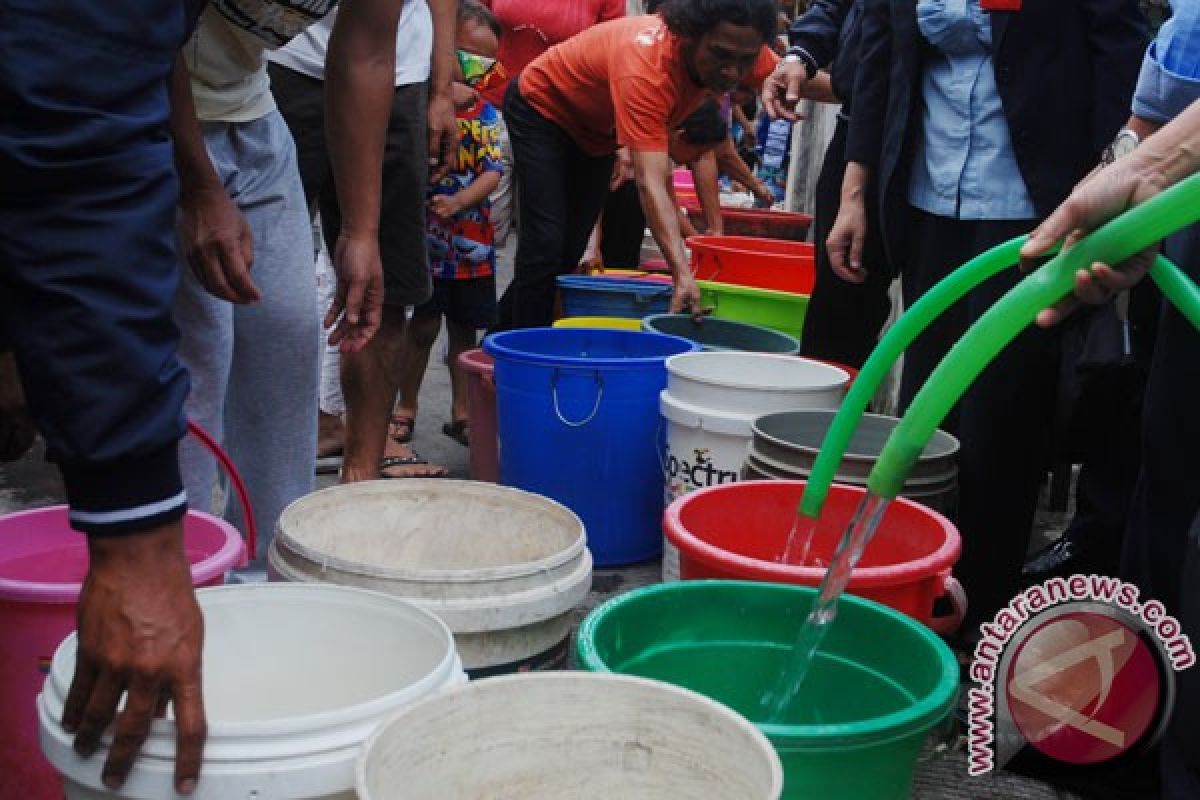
<box><xmin>577</xmin><ymin>581</ymin><xmax>959</xmax><ymax>800</ymax></box>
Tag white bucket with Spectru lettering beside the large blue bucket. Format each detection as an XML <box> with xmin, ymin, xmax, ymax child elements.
<box><xmin>659</xmin><ymin>353</ymin><xmax>850</xmax><ymax>581</ymax></box>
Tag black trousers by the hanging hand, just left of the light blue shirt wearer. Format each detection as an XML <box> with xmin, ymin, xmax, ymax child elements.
<box><xmin>800</xmin><ymin>118</ymin><xmax>892</xmax><ymax>368</ymax></box>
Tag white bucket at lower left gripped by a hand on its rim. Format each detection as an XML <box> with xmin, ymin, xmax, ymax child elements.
<box><xmin>37</xmin><ymin>584</ymin><xmax>466</xmax><ymax>800</ymax></box>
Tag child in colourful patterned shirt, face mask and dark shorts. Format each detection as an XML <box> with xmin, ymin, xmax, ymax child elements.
<box><xmin>400</xmin><ymin>0</ymin><xmax>504</xmax><ymax>445</ymax></box>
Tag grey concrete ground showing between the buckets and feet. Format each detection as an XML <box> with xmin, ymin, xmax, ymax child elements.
<box><xmin>0</xmin><ymin>239</ymin><xmax>1080</xmax><ymax>800</ymax></box>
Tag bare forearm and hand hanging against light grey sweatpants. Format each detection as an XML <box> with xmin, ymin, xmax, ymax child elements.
<box><xmin>170</xmin><ymin>55</ymin><xmax>262</xmax><ymax>303</ymax></box>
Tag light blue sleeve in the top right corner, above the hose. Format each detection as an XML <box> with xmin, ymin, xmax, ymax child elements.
<box><xmin>1133</xmin><ymin>0</ymin><xmax>1200</xmax><ymax>125</ymax></box>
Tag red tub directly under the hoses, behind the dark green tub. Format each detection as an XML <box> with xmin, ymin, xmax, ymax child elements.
<box><xmin>662</xmin><ymin>481</ymin><xmax>966</xmax><ymax>633</ymax></box>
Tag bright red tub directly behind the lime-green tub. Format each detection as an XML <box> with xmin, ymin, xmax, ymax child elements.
<box><xmin>688</xmin><ymin>236</ymin><xmax>816</xmax><ymax>295</ymax></box>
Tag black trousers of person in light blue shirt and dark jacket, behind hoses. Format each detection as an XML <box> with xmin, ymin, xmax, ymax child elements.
<box><xmin>900</xmin><ymin>209</ymin><xmax>1060</xmax><ymax>630</ymax></box>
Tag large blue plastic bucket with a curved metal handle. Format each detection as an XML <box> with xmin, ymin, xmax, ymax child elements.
<box><xmin>484</xmin><ymin>327</ymin><xmax>700</xmax><ymax>566</ymax></box>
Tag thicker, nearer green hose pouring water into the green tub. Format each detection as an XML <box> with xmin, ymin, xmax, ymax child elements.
<box><xmin>868</xmin><ymin>174</ymin><xmax>1200</xmax><ymax>501</ymax></box>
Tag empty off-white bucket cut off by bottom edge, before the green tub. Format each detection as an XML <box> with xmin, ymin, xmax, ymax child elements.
<box><xmin>358</xmin><ymin>673</ymin><xmax>784</xmax><ymax>800</ymax></box>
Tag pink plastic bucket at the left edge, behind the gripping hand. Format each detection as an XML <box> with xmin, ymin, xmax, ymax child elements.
<box><xmin>0</xmin><ymin>506</ymin><xmax>246</xmax><ymax>800</ymax></box>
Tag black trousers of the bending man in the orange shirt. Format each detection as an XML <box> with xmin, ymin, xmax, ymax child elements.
<box><xmin>496</xmin><ymin>80</ymin><xmax>613</xmax><ymax>330</ymax></box>
